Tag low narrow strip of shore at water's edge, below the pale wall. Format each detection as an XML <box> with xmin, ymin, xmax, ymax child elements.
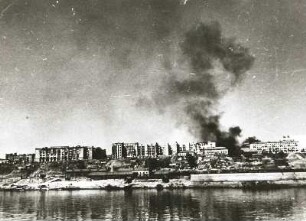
<box><xmin>0</xmin><ymin>179</ymin><xmax>306</xmax><ymax>191</ymax></box>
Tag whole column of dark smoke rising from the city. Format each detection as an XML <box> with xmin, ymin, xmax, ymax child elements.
<box><xmin>148</xmin><ymin>22</ymin><xmax>254</xmax><ymax>155</ymax></box>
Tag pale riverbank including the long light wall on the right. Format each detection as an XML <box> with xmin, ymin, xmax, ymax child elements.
<box><xmin>0</xmin><ymin>172</ymin><xmax>306</xmax><ymax>191</ymax></box>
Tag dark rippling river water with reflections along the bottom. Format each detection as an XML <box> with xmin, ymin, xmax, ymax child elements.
<box><xmin>0</xmin><ymin>188</ymin><xmax>306</xmax><ymax>221</ymax></box>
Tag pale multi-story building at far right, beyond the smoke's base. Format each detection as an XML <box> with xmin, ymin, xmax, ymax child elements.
<box><xmin>250</xmin><ymin>136</ymin><xmax>303</xmax><ymax>153</ymax></box>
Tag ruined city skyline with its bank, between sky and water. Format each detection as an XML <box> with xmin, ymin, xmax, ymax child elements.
<box><xmin>0</xmin><ymin>136</ymin><xmax>306</xmax><ymax>190</ymax></box>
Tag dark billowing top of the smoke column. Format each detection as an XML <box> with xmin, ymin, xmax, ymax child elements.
<box><xmin>181</xmin><ymin>22</ymin><xmax>254</xmax><ymax>84</ymax></box>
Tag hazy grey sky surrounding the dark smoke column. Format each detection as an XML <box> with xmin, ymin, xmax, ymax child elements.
<box><xmin>0</xmin><ymin>0</ymin><xmax>306</xmax><ymax>154</ymax></box>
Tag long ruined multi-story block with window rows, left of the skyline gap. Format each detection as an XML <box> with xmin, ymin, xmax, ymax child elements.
<box><xmin>35</xmin><ymin>146</ymin><xmax>100</xmax><ymax>162</ymax></box>
